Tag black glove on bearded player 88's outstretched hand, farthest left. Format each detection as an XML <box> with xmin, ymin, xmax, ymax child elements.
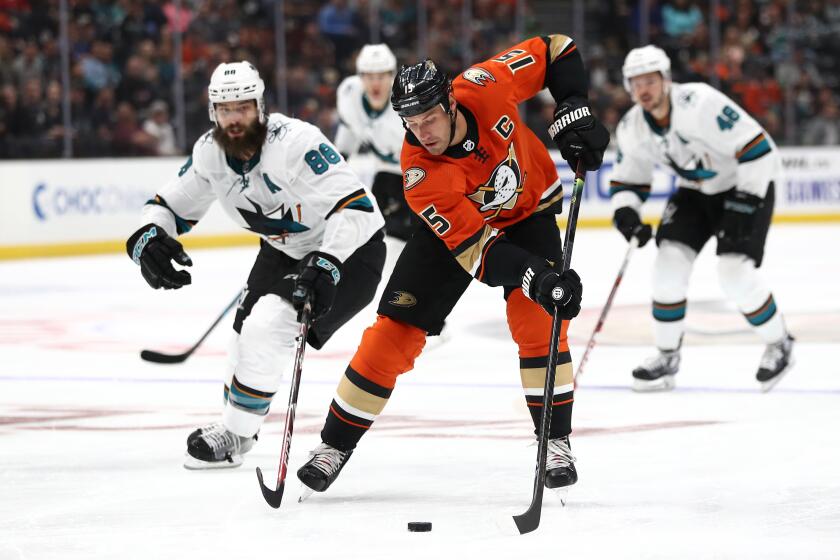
<box><xmin>125</xmin><ymin>224</ymin><xmax>192</xmax><ymax>290</ymax></box>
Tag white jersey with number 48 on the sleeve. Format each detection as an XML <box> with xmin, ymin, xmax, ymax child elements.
<box><xmin>610</xmin><ymin>83</ymin><xmax>782</xmax><ymax>211</ymax></box>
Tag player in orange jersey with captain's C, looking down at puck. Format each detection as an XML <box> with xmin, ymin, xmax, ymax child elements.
<box><xmin>298</xmin><ymin>35</ymin><xmax>609</xmax><ymax>492</ymax></box>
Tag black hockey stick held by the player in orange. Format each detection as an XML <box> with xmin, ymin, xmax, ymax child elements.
<box><xmin>513</xmin><ymin>162</ymin><xmax>586</xmax><ymax>535</ymax></box>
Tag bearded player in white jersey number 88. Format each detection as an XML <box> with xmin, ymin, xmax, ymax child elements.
<box><xmin>127</xmin><ymin>61</ymin><xmax>385</xmax><ymax>469</ymax></box>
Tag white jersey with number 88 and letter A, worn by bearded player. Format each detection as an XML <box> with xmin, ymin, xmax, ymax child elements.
<box><xmin>143</xmin><ymin>113</ymin><xmax>385</xmax><ymax>261</ymax></box>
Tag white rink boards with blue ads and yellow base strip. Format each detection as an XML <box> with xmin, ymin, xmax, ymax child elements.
<box><xmin>0</xmin><ymin>144</ymin><xmax>840</xmax><ymax>259</ymax></box>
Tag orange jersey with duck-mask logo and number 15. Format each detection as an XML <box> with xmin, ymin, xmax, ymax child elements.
<box><xmin>401</xmin><ymin>35</ymin><xmax>576</xmax><ymax>280</ymax></box>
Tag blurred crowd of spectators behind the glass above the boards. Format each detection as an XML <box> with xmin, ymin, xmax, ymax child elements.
<box><xmin>0</xmin><ymin>0</ymin><xmax>840</xmax><ymax>158</ymax></box>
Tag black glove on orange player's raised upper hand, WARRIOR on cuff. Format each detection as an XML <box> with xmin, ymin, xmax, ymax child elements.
<box><xmin>548</xmin><ymin>97</ymin><xmax>610</xmax><ymax>171</ymax></box>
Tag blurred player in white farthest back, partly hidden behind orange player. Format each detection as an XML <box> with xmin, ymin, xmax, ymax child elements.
<box><xmin>335</xmin><ymin>43</ymin><xmax>414</xmax><ymax>239</ymax></box>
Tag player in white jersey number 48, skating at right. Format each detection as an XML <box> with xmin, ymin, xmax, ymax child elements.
<box><xmin>610</xmin><ymin>45</ymin><xmax>793</xmax><ymax>391</ymax></box>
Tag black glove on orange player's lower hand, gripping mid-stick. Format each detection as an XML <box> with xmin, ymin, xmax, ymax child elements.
<box><xmin>522</xmin><ymin>259</ymin><xmax>583</xmax><ymax>320</ymax></box>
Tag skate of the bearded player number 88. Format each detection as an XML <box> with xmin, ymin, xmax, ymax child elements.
<box><xmin>184</xmin><ymin>422</ymin><xmax>257</xmax><ymax>470</ymax></box>
